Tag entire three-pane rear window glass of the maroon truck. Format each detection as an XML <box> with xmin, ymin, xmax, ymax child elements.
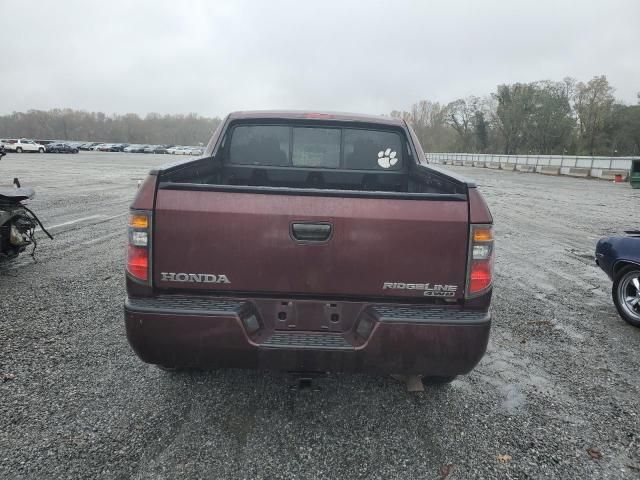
<box><xmin>229</xmin><ymin>125</ymin><xmax>402</xmax><ymax>170</ymax></box>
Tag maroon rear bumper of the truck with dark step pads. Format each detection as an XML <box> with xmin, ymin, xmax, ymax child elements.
<box><xmin>124</xmin><ymin>295</ymin><xmax>491</xmax><ymax>376</ymax></box>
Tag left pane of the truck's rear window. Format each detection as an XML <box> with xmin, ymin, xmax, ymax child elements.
<box><xmin>229</xmin><ymin>125</ymin><xmax>290</xmax><ymax>166</ymax></box>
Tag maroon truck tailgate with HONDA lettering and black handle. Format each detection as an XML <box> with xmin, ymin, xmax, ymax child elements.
<box><xmin>153</xmin><ymin>188</ymin><xmax>469</xmax><ymax>298</ymax></box>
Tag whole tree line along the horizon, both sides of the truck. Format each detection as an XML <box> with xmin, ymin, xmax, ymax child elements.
<box><xmin>0</xmin><ymin>75</ymin><xmax>640</xmax><ymax>155</ymax></box>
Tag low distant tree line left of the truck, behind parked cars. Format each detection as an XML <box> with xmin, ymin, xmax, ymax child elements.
<box><xmin>0</xmin><ymin>109</ymin><xmax>220</xmax><ymax>145</ymax></box>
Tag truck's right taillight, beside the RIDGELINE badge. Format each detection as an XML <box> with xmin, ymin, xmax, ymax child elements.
<box><xmin>467</xmin><ymin>225</ymin><xmax>493</xmax><ymax>298</ymax></box>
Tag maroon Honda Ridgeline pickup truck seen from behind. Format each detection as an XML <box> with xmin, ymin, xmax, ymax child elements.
<box><xmin>124</xmin><ymin>112</ymin><xmax>493</xmax><ymax>381</ymax></box>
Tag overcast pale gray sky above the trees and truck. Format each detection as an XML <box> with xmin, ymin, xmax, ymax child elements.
<box><xmin>0</xmin><ymin>0</ymin><xmax>640</xmax><ymax>116</ymax></box>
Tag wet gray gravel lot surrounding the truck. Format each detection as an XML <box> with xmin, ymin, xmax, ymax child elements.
<box><xmin>0</xmin><ymin>153</ymin><xmax>640</xmax><ymax>479</ymax></box>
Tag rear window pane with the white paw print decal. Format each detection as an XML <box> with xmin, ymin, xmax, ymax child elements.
<box><xmin>344</xmin><ymin>129</ymin><xmax>402</xmax><ymax>170</ymax></box>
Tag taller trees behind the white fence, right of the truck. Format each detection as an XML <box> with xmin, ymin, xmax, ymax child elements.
<box><xmin>391</xmin><ymin>75</ymin><xmax>640</xmax><ymax>155</ymax></box>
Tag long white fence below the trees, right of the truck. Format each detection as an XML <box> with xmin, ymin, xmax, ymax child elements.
<box><xmin>425</xmin><ymin>152</ymin><xmax>640</xmax><ymax>172</ymax></box>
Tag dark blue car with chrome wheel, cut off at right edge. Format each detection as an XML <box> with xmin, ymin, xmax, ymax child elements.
<box><xmin>596</xmin><ymin>231</ymin><xmax>640</xmax><ymax>327</ymax></box>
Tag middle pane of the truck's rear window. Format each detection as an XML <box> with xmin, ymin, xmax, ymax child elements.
<box><xmin>292</xmin><ymin>127</ymin><xmax>340</xmax><ymax>168</ymax></box>
